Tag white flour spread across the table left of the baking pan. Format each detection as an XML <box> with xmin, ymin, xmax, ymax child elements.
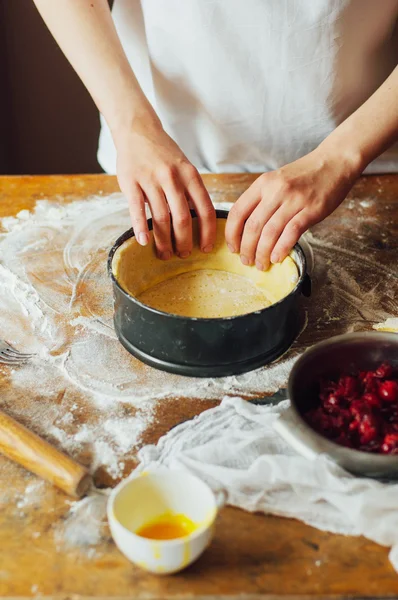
<box><xmin>0</xmin><ymin>194</ymin><xmax>297</xmax><ymax>478</ymax></box>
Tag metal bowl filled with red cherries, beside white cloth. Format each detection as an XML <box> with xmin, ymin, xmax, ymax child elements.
<box><xmin>275</xmin><ymin>332</ymin><xmax>398</xmax><ymax>479</ymax></box>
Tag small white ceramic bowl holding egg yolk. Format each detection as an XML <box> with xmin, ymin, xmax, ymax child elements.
<box><xmin>108</xmin><ymin>471</ymin><xmax>226</xmax><ymax>574</ymax></box>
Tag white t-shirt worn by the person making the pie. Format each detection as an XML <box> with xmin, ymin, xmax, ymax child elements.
<box><xmin>98</xmin><ymin>0</ymin><xmax>398</xmax><ymax>173</ymax></box>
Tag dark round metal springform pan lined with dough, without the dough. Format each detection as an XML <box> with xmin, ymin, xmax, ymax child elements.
<box><xmin>108</xmin><ymin>210</ymin><xmax>310</xmax><ymax>377</ymax></box>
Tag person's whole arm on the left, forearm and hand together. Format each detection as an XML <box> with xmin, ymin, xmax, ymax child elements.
<box><xmin>34</xmin><ymin>0</ymin><xmax>216</xmax><ymax>259</ymax></box>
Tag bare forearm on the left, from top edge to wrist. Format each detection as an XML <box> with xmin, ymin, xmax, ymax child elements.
<box><xmin>34</xmin><ymin>0</ymin><xmax>159</xmax><ymax>137</ymax></box>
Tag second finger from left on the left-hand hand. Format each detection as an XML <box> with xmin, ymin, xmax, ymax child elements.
<box><xmin>145</xmin><ymin>186</ymin><xmax>173</xmax><ymax>260</ymax></box>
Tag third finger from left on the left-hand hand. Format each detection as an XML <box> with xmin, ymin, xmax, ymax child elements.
<box><xmin>163</xmin><ymin>180</ymin><xmax>192</xmax><ymax>258</ymax></box>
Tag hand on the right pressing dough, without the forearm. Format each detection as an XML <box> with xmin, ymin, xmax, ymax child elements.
<box><xmin>226</xmin><ymin>146</ymin><xmax>361</xmax><ymax>270</ymax></box>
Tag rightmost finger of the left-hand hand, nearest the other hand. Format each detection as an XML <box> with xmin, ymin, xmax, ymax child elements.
<box><xmin>183</xmin><ymin>167</ymin><xmax>216</xmax><ymax>252</ymax></box>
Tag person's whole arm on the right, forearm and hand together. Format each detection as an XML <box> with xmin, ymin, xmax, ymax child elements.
<box><xmin>226</xmin><ymin>68</ymin><xmax>398</xmax><ymax>270</ymax></box>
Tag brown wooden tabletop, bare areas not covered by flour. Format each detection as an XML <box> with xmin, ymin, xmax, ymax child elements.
<box><xmin>0</xmin><ymin>175</ymin><xmax>398</xmax><ymax>599</ymax></box>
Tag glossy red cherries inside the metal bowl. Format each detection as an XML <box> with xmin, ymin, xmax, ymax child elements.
<box><xmin>304</xmin><ymin>363</ymin><xmax>398</xmax><ymax>454</ymax></box>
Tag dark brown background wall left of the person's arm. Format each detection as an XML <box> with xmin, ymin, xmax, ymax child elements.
<box><xmin>0</xmin><ymin>0</ymin><xmax>109</xmax><ymax>174</ymax></box>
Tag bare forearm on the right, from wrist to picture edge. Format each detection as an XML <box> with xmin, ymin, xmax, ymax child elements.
<box><xmin>320</xmin><ymin>67</ymin><xmax>398</xmax><ymax>175</ymax></box>
